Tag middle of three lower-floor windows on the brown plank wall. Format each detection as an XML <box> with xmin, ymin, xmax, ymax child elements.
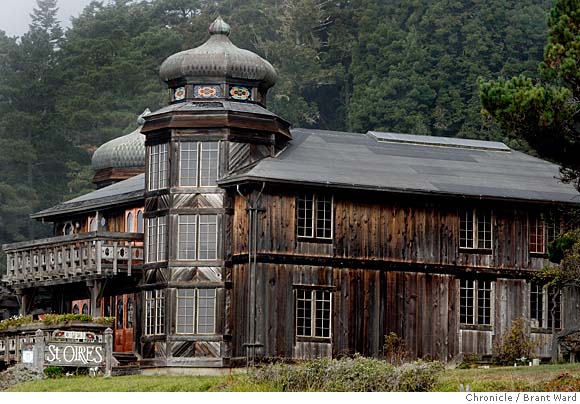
<box><xmin>459</xmin><ymin>278</ymin><xmax>495</xmax><ymax>330</ymax></box>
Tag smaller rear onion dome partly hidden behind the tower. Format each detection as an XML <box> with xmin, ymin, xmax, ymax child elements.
<box><xmin>91</xmin><ymin>109</ymin><xmax>150</xmax><ymax>188</ymax></box>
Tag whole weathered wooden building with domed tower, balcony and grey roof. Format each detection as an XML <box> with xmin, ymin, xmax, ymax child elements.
<box><xmin>4</xmin><ymin>18</ymin><xmax>580</xmax><ymax>371</ymax></box>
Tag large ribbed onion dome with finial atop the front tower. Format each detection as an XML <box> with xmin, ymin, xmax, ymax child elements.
<box><xmin>159</xmin><ymin>17</ymin><xmax>277</xmax><ymax>89</ymax></box>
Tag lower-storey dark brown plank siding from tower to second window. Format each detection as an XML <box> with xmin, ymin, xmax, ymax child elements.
<box><xmin>231</xmin><ymin>264</ymin><xmax>459</xmax><ymax>360</ymax></box>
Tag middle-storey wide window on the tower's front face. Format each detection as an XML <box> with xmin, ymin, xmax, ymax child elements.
<box><xmin>176</xmin><ymin>213</ymin><xmax>220</xmax><ymax>261</ymax></box>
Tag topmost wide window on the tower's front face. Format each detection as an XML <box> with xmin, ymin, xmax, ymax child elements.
<box><xmin>179</xmin><ymin>142</ymin><xmax>219</xmax><ymax>187</ymax></box>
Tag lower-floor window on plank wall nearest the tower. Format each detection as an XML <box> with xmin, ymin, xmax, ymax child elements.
<box><xmin>296</xmin><ymin>289</ymin><xmax>331</xmax><ymax>338</ymax></box>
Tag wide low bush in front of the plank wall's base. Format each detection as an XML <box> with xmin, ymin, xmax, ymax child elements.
<box><xmin>252</xmin><ymin>356</ymin><xmax>443</xmax><ymax>392</ymax></box>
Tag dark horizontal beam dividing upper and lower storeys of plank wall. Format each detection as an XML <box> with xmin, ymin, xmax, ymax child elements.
<box><xmin>232</xmin><ymin>253</ymin><xmax>537</xmax><ymax>279</ymax></box>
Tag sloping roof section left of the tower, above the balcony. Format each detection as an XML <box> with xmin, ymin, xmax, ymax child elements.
<box><xmin>30</xmin><ymin>174</ymin><xmax>145</xmax><ymax>219</ymax></box>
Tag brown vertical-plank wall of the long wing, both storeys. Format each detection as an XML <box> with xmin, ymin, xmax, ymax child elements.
<box><xmin>230</xmin><ymin>190</ymin><xmax>572</xmax><ymax>361</ymax></box>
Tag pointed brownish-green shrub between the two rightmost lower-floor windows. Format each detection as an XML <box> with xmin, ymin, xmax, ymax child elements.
<box><xmin>494</xmin><ymin>318</ymin><xmax>534</xmax><ymax>365</ymax></box>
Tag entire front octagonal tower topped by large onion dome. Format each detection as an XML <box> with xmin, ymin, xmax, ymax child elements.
<box><xmin>140</xmin><ymin>17</ymin><xmax>291</xmax><ymax>367</ymax></box>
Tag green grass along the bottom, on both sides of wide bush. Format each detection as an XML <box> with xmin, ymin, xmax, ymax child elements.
<box><xmin>8</xmin><ymin>364</ymin><xmax>580</xmax><ymax>392</ymax></box>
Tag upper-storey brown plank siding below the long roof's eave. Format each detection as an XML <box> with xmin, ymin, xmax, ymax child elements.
<box><xmin>233</xmin><ymin>193</ymin><xmax>547</xmax><ymax>270</ymax></box>
